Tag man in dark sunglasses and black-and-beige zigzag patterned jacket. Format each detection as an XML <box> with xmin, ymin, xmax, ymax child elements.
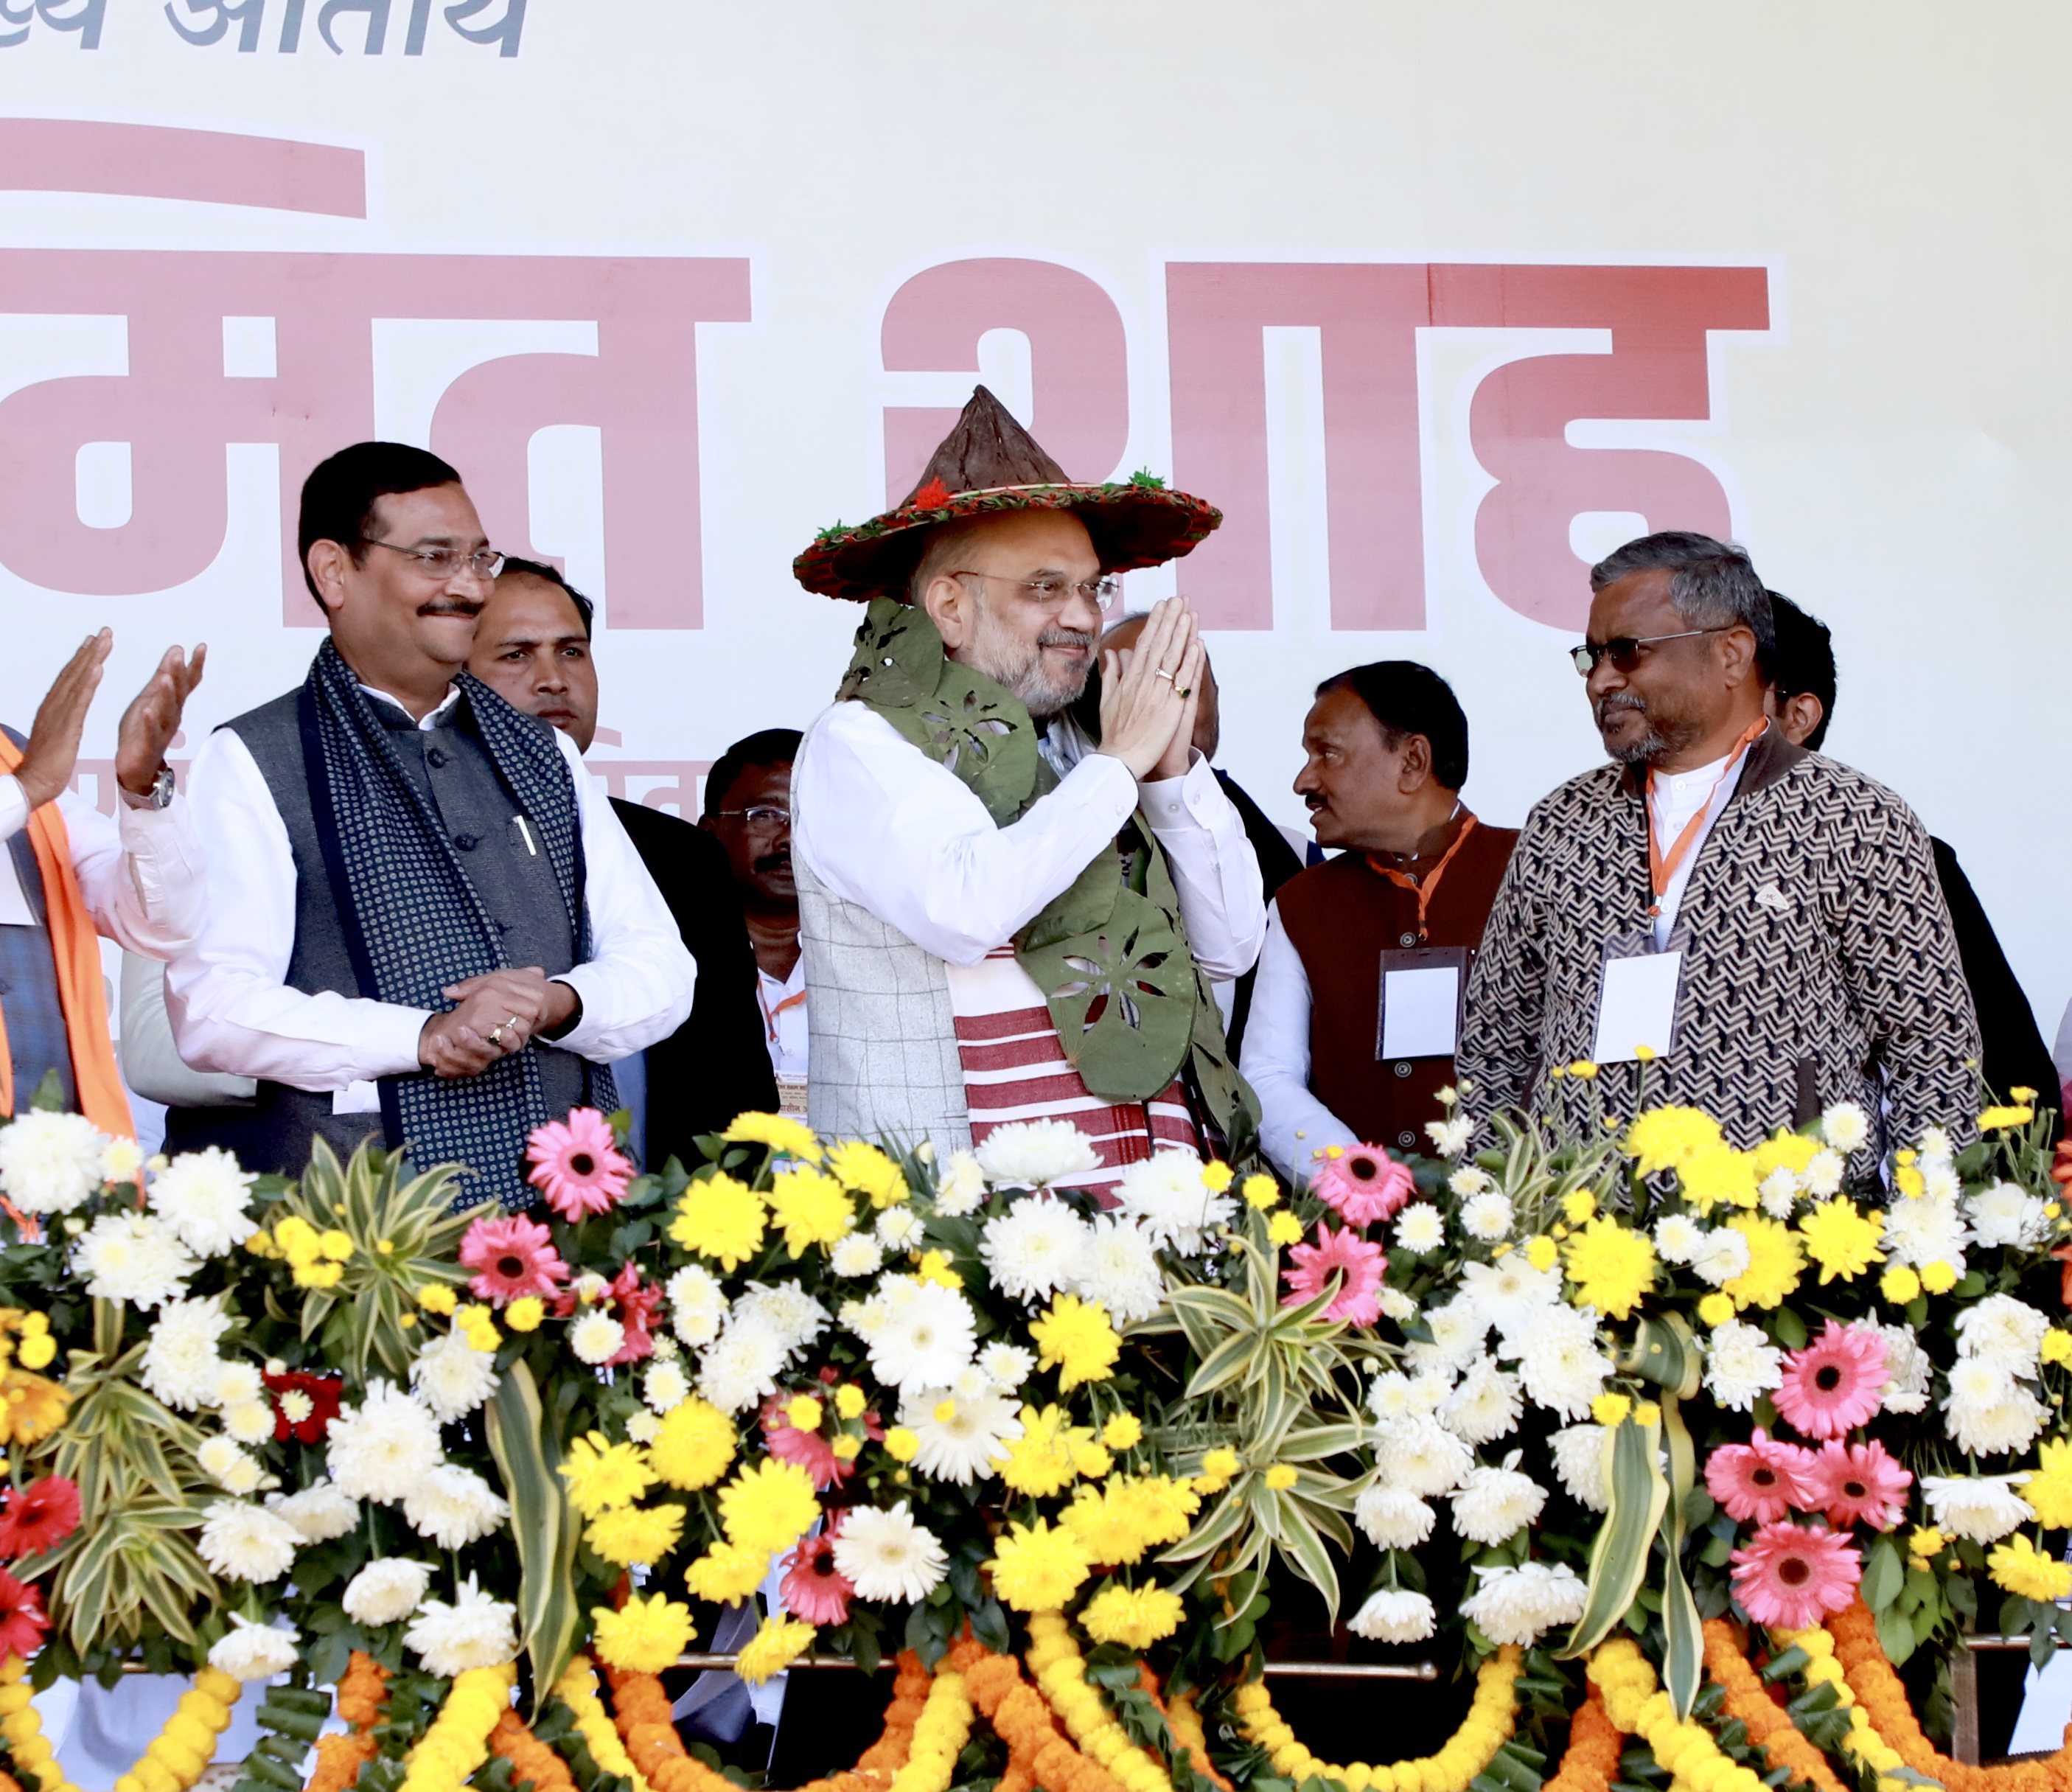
<box><xmin>1459</xmin><ymin>530</ymin><xmax>1979</xmax><ymax>1152</ymax></box>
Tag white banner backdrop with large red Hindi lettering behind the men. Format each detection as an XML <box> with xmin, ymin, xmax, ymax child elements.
<box><xmin>0</xmin><ymin>0</ymin><xmax>2072</xmax><ymax>1036</ymax></box>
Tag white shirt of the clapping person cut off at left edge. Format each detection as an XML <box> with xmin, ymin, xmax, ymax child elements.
<box><xmin>0</xmin><ymin>775</ymin><xmax>207</xmax><ymax>959</ymax></box>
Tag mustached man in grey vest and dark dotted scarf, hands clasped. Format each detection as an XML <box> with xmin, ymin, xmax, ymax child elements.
<box><xmin>166</xmin><ymin>442</ymin><xmax>696</xmax><ymax>1206</ymax></box>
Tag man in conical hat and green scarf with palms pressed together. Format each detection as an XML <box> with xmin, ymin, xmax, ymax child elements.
<box><xmin>792</xmin><ymin>388</ymin><xmax>1266</xmax><ymax>1189</ymax></box>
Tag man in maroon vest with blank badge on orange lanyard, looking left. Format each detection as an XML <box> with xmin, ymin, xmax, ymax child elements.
<box><xmin>1243</xmin><ymin>659</ymin><xmax>1518</xmax><ymax>1176</ymax></box>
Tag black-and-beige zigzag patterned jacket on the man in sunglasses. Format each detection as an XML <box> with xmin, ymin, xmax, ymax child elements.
<box><xmin>1459</xmin><ymin>729</ymin><xmax>1979</xmax><ymax>1148</ymax></box>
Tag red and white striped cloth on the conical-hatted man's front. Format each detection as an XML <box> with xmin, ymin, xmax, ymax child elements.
<box><xmin>949</xmin><ymin>946</ymin><xmax>1201</xmax><ymax>1189</ymax></box>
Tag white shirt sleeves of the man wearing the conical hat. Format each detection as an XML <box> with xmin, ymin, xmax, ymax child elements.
<box><xmin>792</xmin><ymin>702</ymin><xmax>1266</xmax><ymax>977</ymax></box>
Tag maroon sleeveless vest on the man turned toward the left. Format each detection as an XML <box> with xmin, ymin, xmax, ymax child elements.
<box><xmin>1274</xmin><ymin>823</ymin><xmax>1518</xmax><ymax>1150</ymax></box>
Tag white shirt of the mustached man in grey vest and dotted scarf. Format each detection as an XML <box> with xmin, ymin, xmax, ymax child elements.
<box><xmin>166</xmin><ymin>686</ymin><xmax>696</xmax><ymax>1112</ymax></box>
